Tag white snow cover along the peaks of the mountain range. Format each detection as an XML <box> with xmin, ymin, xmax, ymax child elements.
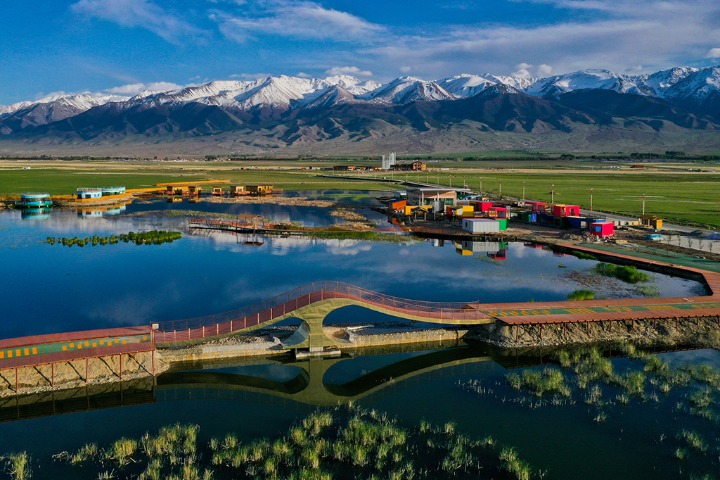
<box><xmin>0</xmin><ymin>66</ymin><xmax>720</xmax><ymax>120</ymax></box>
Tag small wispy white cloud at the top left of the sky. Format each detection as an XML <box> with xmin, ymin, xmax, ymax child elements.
<box><xmin>71</xmin><ymin>0</ymin><xmax>201</xmax><ymax>43</ymax></box>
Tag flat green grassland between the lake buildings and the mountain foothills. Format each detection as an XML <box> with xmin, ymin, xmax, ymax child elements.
<box><xmin>0</xmin><ymin>161</ymin><xmax>720</xmax><ymax>228</ymax></box>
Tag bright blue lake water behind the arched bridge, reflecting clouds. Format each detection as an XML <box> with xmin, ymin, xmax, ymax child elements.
<box><xmin>0</xmin><ymin>203</ymin><xmax>702</xmax><ymax>337</ymax></box>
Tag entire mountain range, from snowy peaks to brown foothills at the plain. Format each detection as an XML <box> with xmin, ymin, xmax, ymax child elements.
<box><xmin>0</xmin><ymin>66</ymin><xmax>720</xmax><ymax>153</ymax></box>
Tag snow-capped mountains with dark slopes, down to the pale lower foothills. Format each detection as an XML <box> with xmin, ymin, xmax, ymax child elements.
<box><xmin>0</xmin><ymin>66</ymin><xmax>720</xmax><ymax>148</ymax></box>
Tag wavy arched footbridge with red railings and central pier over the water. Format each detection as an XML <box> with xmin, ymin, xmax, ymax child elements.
<box><xmin>153</xmin><ymin>281</ymin><xmax>495</xmax><ymax>350</ymax></box>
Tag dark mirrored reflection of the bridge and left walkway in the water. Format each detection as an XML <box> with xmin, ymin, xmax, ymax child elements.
<box><xmin>0</xmin><ymin>346</ymin><xmax>500</xmax><ymax>421</ymax></box>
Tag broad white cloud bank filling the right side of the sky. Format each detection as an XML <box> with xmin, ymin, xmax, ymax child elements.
<box><xmin>368</xmin><ymin>0</ymin><xmax>720</xmax><ymax>78</ymax></box>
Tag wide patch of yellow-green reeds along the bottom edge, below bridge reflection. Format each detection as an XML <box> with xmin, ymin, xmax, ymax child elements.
<box><xmin>47</xmin><ymin>403</ymin><xmax>531</xmax><ymax>480</ymax></box>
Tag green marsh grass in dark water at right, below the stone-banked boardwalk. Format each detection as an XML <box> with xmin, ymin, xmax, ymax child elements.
<box><xmin>484</xmin><ymin>343</ymin><xmax>720</xmax><ymax>432</ymax></box>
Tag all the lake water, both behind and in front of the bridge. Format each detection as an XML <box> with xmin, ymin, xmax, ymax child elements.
<box><xmin>0</xmin><ymin>197</ymin><xmax>720</xmax><ymax>479</ymax></box>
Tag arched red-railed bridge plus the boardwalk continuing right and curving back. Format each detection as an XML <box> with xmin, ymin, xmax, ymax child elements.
<box><xmin>154</xmin><ymin>242</ymin><xmax>720</xmax><ymax>351</ymax></box>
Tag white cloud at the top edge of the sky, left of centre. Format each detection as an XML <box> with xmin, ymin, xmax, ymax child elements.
<box><xmin>210</xmin><ymin>1</ymin><xmax>382</xmax><ymax>42</ymax></box>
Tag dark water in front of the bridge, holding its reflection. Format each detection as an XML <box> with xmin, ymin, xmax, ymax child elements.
<box><xmin>0</xmin><ymin>347</ymin><xmax>720</xmax><ymax>479</ymax></box>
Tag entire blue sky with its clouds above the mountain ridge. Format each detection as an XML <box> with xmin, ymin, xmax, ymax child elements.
<box><xmin>0</xmin><ymin>0</ymin><xmax>720</xmax><ymax>105</ymax></box>
